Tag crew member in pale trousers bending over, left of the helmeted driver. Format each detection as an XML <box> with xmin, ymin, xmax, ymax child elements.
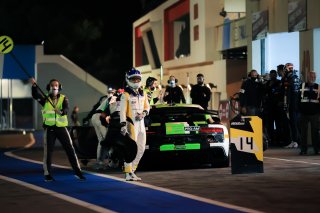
<box><xmin>91</xmin><ymin>97</ymin><xmax>111</xmax><ymax>170</ymax></box>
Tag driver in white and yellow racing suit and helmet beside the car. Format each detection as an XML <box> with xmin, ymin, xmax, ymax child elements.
<box><xmin>120</xmin><ymin>68</ymin><xmax>150</xmax><ymax>181</ymax></box>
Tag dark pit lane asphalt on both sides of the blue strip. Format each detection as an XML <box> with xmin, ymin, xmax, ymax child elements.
<box><xmin>0</xmin><ymin>147</ymin><xmax>320</xmax><ymax>213</ymax></box>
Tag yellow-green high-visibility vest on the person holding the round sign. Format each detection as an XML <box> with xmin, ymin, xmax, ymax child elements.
<box><xmin>42</xmin><ymin>94</ymin><xmax>68</xmax><ymax>127</ymax></box>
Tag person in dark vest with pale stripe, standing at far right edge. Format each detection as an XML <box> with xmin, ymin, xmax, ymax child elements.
<box><xmin>299</xmin><ymin>71</ymin><xmax>320</xmax><ymax>155</ymax></box>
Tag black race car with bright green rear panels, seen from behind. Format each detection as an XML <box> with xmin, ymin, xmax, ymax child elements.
<box><xmin>141</xmin><ymin>104</ymin><xmax>230</xmax><ymax>167</ymax></box>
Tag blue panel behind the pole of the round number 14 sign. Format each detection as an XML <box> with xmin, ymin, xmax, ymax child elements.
<box><xmin>0</xmin><ymin>45</ymin><xmax>36</xmax><ymax>80</ymax></box>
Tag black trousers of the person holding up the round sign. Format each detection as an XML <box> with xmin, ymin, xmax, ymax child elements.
<box><xmin>43</xmin><ymin>126</ymin><xmax>81</xmax><ymax>175</ymax></box>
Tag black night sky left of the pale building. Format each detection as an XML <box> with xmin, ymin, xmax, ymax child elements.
<box><xmin>0</xmin><ymin>0</ymin><xmax>165</xmax><ymax>87</ymax></box>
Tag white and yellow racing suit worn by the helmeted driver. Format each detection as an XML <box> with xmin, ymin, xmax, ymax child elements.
<box><xmin>120</xmin><ymin>87</ymin><xmax>150</xmax><ymax>173</ymax></box>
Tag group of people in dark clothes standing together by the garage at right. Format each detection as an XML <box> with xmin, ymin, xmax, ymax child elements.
<box><xmin>239</xmin><ymin>63</ymin><xmax>320</xmax><ymax>155</ymax></box>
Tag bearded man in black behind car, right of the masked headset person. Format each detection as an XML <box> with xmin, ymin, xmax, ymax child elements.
<box><xmin>190</xmin><ymin>73</ymin><xmax>211</xmax><ymax>110</ymax></box>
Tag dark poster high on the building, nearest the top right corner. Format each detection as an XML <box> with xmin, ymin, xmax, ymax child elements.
<box><xmin>288</xmin><ymin>0</ymin><xmax>307</xmax><ymax>32</ymax></box>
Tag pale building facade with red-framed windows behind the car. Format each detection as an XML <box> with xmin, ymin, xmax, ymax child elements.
<box><xmin>133</xmin><ymin>0</ymin><xmax>320</xmax><ymax>113</ymax></box>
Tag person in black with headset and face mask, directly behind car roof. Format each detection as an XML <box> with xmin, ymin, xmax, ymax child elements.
<box><xmin>163</xmin><ymin>76</ymin><xmax>186</xmax><ymax>104</ymax></box>
